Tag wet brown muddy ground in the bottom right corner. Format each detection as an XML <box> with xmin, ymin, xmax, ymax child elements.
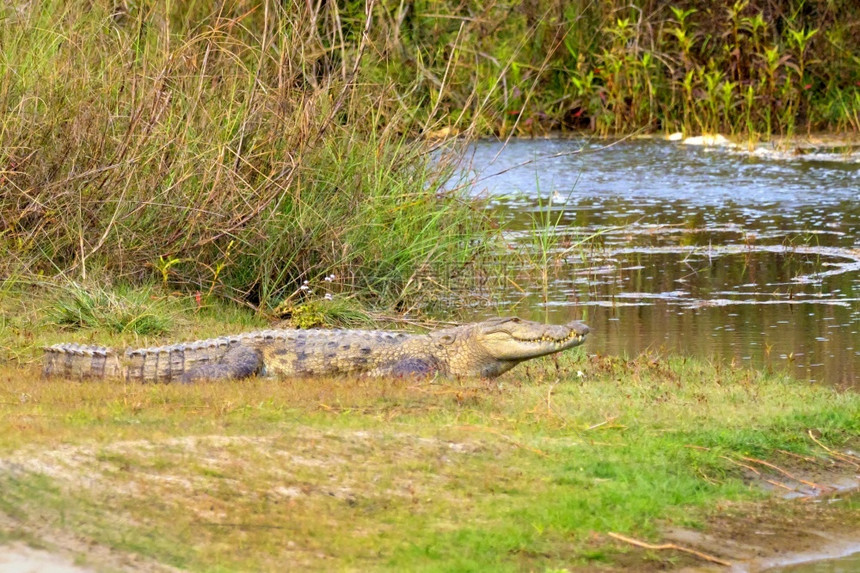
<box><xmin>608</xmin><ymin>461</ymin><xmax>860</xmax><ymax>573</ymax></box>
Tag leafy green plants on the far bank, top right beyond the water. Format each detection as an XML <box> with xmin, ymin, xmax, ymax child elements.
<box><xmin>548</xmin><ymin>0</ymin><xmax>860</xmax><ymax>138</ymax></box>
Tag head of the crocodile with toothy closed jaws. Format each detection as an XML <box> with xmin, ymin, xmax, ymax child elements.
<box><xmin>439</xmin><ymin>318</ymin><xmax>588</xmax><ymax>378</ymax></box>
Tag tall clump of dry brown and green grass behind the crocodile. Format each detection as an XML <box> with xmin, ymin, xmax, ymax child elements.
<box><xmin>0</xmin><ymin>1</ymin><xmax>494</xmax><ymax>309</ymax></box>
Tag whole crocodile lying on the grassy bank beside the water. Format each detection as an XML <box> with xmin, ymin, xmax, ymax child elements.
<box><xmin>43</xmin><ymin>318</ymin><xmax>588</xmax><ymax>383</ymax></box>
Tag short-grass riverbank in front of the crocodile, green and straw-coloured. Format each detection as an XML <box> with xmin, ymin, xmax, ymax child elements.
<box><xmin>0</xmin><ymin>318</ymin><xmax>860</xmax><ymax>571</ymax></box>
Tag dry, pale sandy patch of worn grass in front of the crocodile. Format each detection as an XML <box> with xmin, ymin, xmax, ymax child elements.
<box><xmin>0</xmin><ymin>428</ymin><xmax>483</xmax><ymax>519</ymax></box>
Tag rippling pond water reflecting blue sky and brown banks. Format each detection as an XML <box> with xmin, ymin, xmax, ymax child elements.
<box><xmin>466</xmin><ymin>139</ymin><xmax>860</xmax><ymax>388</ymax></box>
